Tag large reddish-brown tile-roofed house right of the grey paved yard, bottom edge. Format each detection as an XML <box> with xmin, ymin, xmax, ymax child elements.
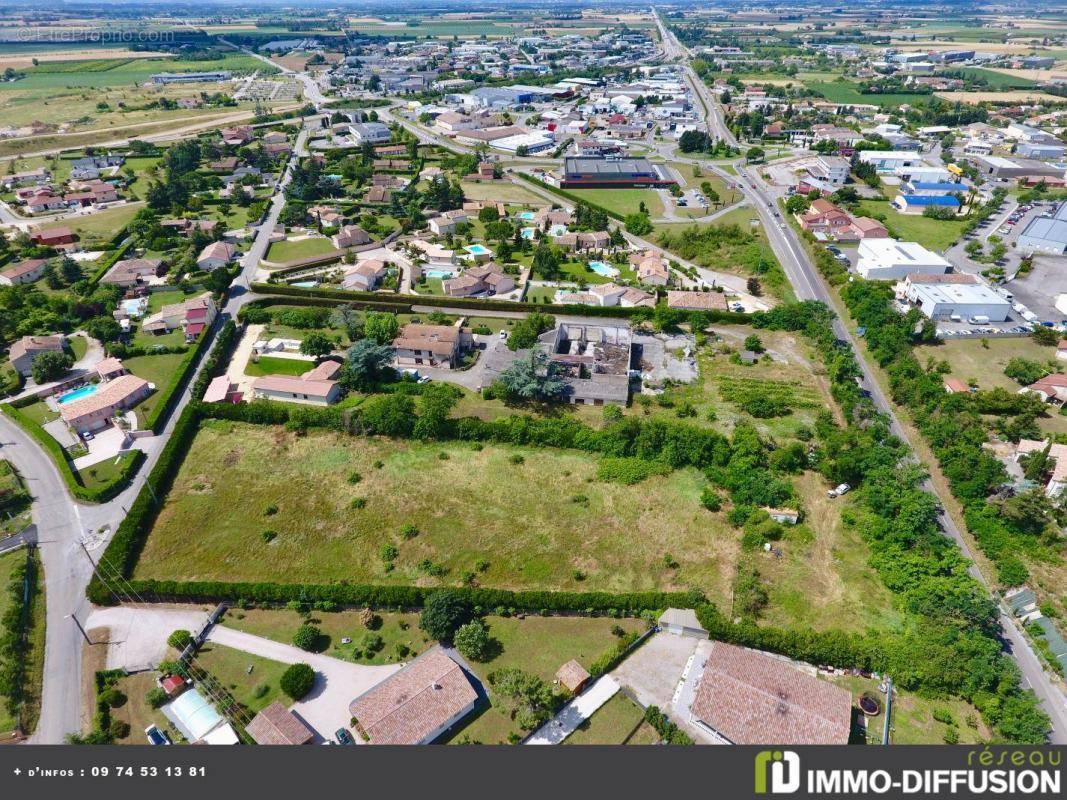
<box><xmin>689</xmin><ymin>642</ymin><xmax>853</xmax><ymax>745</ymax></box>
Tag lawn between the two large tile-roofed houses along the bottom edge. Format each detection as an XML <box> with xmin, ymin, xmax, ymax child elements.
<box><xmin>441</xmin><ymin>617</ymin><xmax>644</xmax><ymax>745</ymax></box>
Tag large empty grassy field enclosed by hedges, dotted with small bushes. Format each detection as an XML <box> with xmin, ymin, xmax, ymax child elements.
<box><xmin>136</xmin><ymin>422</ymin><xmax>737</xmax><ymax>599</ymax></box>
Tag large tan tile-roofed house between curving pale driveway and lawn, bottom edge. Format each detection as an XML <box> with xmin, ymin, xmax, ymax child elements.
<box><xmin>349</xmin><ymin>646</ymin><xmax>478</xmax><ymax>745</ymax></box>
